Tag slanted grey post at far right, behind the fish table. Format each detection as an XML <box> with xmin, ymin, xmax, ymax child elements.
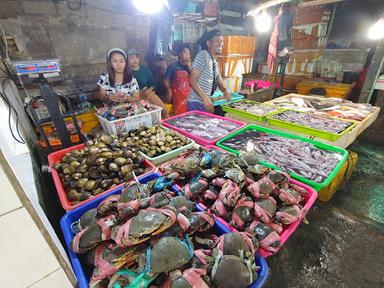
<box><xmin>358</xmin><ymin>39</ymin><xmax>384</xmax><ymax>103</ymax></box>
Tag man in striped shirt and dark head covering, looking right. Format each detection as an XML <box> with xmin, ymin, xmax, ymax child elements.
<box><xmin>188</xmin><ymin>29</ymin><xmax>231</xmax><ymax>112</ymax></box>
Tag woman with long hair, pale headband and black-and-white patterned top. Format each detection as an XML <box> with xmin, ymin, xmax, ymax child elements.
<box><xmin>97</xmin><ymin>48</ymin><xmax>140</xmax><ymax>102</ymax></box>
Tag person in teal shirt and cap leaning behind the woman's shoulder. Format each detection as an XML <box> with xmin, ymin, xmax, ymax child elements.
<box><xmin>128</xmin><ymin>49</ymin><xmax>169</xmax><ymax>118</ymax></box>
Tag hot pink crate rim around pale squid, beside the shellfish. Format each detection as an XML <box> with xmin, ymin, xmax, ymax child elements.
<box><xmin>161</xmin><ymin>110</ymin><xmax>246</xmax><ymax>146</ymax></box>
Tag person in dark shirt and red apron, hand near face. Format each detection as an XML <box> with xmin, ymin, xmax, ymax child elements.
<box><xmin>164</xmin><ymin>44</ymin><xmax>192</xmax><ymax>115</ymax></box>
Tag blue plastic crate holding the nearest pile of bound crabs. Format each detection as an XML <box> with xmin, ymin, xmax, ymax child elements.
<box><xmin>60</xmin><ymin>173</ymin><xmax>268</xmax><ymax>288</ymax></box>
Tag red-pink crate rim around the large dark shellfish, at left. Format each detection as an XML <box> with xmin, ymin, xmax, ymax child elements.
<box><xmin>48</xmin><ymin>144</ymin><xmax>156</xmax><ymax>211</ymax></box>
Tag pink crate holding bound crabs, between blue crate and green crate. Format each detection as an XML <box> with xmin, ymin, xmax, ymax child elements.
<box><xmin>159</xmin><ymin>145</ymin><xmax>318</xmax><ymax>258</ymax></box>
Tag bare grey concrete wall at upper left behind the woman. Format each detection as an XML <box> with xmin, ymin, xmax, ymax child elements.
<box><xmin>0</xmin><ymin>0</ymin><xmax>151</xmax><ymax>90</ymax></box>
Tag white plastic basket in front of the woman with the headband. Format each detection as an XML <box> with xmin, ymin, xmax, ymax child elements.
<box><xmin>96</xmin><ymin>108</ymin><xmax>162</xmax><ymax>135</ymax></box>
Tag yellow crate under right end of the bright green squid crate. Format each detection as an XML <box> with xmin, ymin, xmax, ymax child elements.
<box><xmin>317</xmin><ymin>150</ymin><xmax>359</xmax><ymax>202</ymax></box>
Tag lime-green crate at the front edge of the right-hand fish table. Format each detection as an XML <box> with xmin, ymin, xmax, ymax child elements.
<box><xmin>266</xmin><ymin>109</ymin><xmax>356</xmax><ymax>142</ymax></box>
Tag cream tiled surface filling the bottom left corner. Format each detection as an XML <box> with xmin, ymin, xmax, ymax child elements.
<box><xmin>0</xmin><ymin>167</ymin><xmax>72</xmax><ymax>288</ymax></box>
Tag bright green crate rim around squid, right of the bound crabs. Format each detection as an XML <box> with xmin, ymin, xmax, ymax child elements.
<box><xmin>216</xmin><ymin>125</ymin><xmax>348</xmax><ymax>191</ymax></box>
